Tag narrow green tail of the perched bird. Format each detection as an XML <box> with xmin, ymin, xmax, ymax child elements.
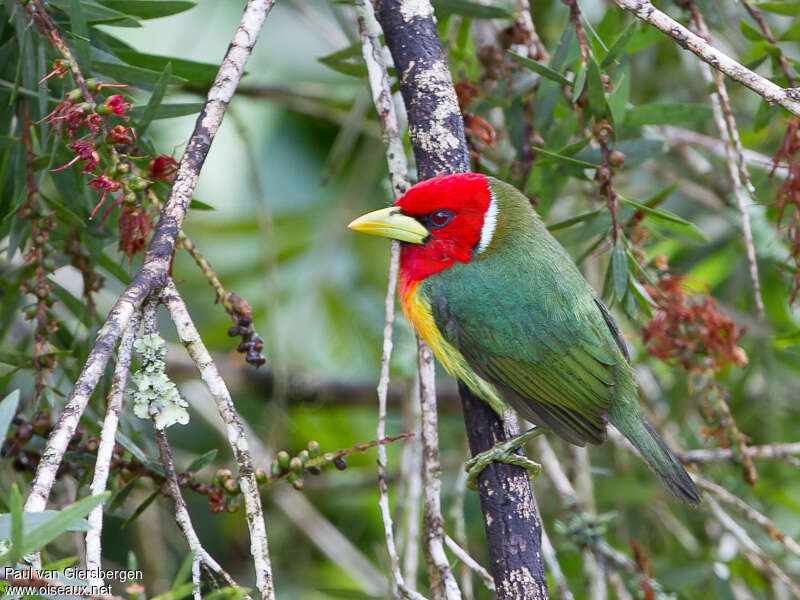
<box><xmin>608</xmin><ymin>399</ymin><xmax>701</xmax><ymax>506</ymax></box>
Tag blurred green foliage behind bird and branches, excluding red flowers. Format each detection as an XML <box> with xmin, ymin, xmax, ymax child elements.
<box><xmin>0</xmin><ymin>0</ymin><xmax>800</xmax><ymax>600</ymax></box>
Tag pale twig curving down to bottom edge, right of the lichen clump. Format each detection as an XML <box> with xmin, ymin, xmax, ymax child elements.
<box><xmin>161</xmin><ymin>280</ymin><xmax>275</xmax><ymax>600</ymax></box>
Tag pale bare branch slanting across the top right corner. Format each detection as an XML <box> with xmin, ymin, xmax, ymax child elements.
<box><xmin>614</xmin><ymin>0</ymin><xmax>800</xmax><ymax>116</ymax></box>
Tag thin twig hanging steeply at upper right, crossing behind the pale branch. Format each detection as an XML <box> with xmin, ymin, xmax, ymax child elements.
<box><xmin>689</xmin><ymin>2</ymin><xmax>764</xmax><ymax>320</ymax></box>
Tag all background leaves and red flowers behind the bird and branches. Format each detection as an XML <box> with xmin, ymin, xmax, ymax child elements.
<box><xmin>0</xmin><ymin>0</ymin><xmax>800</xmax><ymax>599</ymax></box>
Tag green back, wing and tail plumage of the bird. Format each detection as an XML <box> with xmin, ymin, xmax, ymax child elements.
<box><xmin>420</xmin><ymin>179</ymin><xmax>700</xmax><ymax>504</ymax></box>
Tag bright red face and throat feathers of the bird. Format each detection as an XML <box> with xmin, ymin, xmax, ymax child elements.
<box><xmin>396</xmin><ymin>173</ymin><xmax>491</xmax><ymax>298</ymax></box>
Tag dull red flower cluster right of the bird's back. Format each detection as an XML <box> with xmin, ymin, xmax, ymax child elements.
<box><xmin>642</xmin><ymin>275</ymin><xmax>748</xmax><ymax>371</ymax></box>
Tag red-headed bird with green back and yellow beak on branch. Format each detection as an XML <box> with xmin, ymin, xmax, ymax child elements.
<box><xmin>348</xmin><ymin>173</ymin><xmax>701</xmax><ymax>506</ymax></box>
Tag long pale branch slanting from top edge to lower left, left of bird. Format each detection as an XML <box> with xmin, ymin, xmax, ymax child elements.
<box><xmin>25</xmin><ymin>0</ymin><xmax>274</xmax><ymax>512</ymax></box>
